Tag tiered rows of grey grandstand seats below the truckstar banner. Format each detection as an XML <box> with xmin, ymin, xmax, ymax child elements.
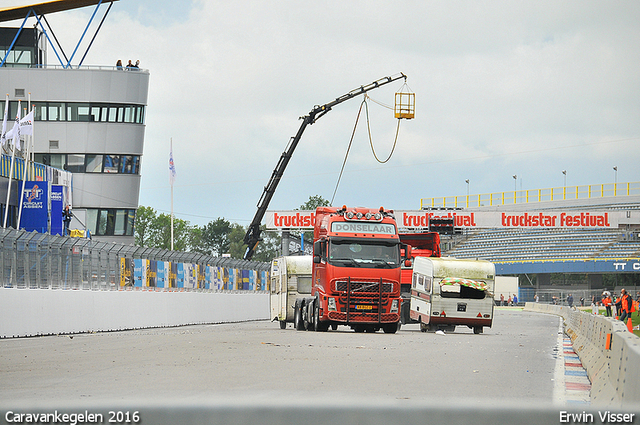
<box><xmin>443</xmin><ymin>229</ymin><xmax>640</xmax><ymax>262</ymax></box>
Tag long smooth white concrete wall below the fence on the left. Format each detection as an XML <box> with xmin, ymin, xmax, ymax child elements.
<box><xmin>0</xmin><ymin>288</ymin><xmax>269</xmax><ymax>338</ymax></box>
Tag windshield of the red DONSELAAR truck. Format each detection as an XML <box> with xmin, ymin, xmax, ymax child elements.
<box><xmin>329</xmin><ymin>238</ymin><xmax>400</xmax><ymax>269</ymax></box>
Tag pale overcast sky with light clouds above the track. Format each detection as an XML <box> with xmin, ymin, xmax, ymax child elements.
<box><xmin>5</xmin><ymin>0</ymin><xmax>640</xmax><ymax>225</ymax></box>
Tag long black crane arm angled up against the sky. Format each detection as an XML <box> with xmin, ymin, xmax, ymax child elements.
<box><xmin>244</xmin><ymin>73</ymin><xmax>407</xmax><ymax>260</ymax></box>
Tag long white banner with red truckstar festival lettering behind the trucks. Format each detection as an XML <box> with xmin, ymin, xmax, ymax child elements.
<box><xmin>265</xmin><ymin>210</ymin><xmax>640</xmax><ymax>229</ymax></box>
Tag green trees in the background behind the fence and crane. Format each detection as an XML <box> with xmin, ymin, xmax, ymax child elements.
<box><xmin>134</xmin><ymin>195</ymin><xmax>329</xmax><ymax>262</ymax></box>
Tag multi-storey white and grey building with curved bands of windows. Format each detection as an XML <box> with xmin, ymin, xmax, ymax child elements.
<box><xmin>0</xmin><ymin>2</ymin><xmax>149</xmax><ymax>244</ymax></box>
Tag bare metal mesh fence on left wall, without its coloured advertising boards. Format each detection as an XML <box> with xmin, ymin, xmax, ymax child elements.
<box><xmin>0</xmin><ymin>229</ymin><xmax>269</xmax><ymax>291</ymax></box>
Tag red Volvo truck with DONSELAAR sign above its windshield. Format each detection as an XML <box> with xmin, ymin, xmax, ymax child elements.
<box><xmin>294</xmin><ymin>206</ymin><xmax>402</xmax><ymax>333</ymax></box>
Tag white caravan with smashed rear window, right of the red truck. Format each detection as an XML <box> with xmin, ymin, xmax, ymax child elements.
<box><xmin>410</xmin><ymin>257</ymin><xmax>495</xmax><ymax>334</ymax></box>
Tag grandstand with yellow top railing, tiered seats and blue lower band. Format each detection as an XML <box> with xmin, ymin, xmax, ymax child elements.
<box><xmin>421</xmin><ymin>183</ymin><xmax>640</xmax><ymax>301</ymax></box>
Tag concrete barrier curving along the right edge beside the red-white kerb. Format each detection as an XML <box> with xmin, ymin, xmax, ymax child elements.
<box><xmin>525</xmin><ymin>303</ymin><xmax>640</xmax><ymax>406</ymax></box>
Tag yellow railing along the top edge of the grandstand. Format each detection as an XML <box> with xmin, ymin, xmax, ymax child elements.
<box><xmin>420</xmin><ymin>182</ymin><xmax>640</xmax><ymax>209</ymax></box>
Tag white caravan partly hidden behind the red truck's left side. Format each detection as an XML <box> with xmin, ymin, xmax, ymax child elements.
<box><xmin>269</xmin><ymin>255</ymin><xmax>313</xmax><ymax>329</ymax></box>
